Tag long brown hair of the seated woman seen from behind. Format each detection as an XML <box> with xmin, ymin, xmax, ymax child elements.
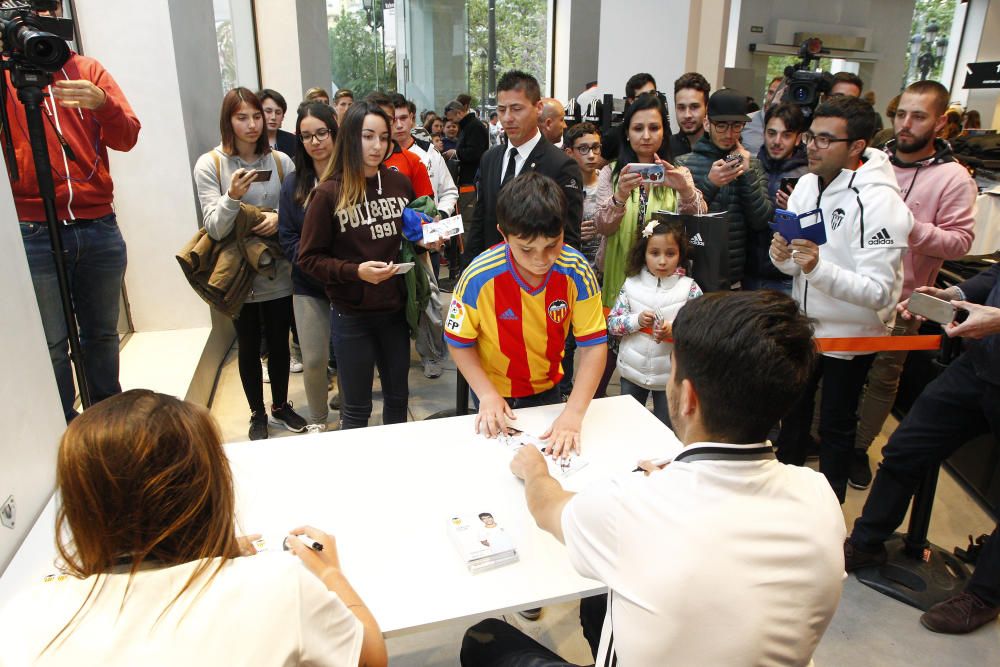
<box><xmin>47</xmin><ymin>389</ymin><xmax>240</xmax><ymax>648</ymax></box>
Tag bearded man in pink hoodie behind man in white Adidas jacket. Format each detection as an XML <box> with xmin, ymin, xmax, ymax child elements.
<box><xmin>849</xmin><ymin>81</ymin><xmax>976</xmax><ymax>489</ymax></box>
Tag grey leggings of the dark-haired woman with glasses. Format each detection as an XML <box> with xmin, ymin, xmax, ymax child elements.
<box><xmin>292</xmin><ymin>294</ymin><xmax>330</xmax><ymax>424</ymax></box>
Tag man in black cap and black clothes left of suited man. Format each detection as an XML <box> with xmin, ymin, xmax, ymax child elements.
<box><xmin>442</xmin><ymin>100</ymin><xmax>490</xmax><ymax>289</ymax></box>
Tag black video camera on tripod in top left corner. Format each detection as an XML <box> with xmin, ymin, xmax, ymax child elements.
<box><xmin>0</xmin><ymin>0</ymin><xmax>74</xmax><ymax>73</ymax></box>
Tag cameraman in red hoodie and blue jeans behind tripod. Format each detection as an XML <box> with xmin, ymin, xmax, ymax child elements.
<box><xmin>0</xmin><ymin>3</ymin><xmax>140</xmax><ymax>422</ymax></box>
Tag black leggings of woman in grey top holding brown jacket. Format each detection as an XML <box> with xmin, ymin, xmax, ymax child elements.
<box><xmin>234</xmin><ymin>296</ymin><xmax>292</xmax><ymax>412</ymax></box>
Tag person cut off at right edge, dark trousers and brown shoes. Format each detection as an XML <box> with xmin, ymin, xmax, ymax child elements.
<box><xmin>844</xmin><ymin>264</ymin><xmax>1000</xmax><ymax>634</ymax></box>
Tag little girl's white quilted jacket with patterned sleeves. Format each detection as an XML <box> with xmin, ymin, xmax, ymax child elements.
<box><xmin>609</xmin><ymin>268</ymin><xmax>701</xmax><ymax>390</ymax></box>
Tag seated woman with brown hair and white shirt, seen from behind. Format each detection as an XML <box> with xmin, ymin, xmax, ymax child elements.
<box><xmin>0</xmin><ymin>389</ymin><xmax>387</xmax><ymax>667</ymax></box>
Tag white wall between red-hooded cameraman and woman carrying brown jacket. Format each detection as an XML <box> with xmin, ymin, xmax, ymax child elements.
<box><xmin>76</xmin><ymin>0</ymin><xmax>222</xmax><ymax>331</ymax></box>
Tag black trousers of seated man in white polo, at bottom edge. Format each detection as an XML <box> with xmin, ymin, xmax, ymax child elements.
<box><xmin>459</xmin><ymin>618</ymin><xmax>576</xmax><ymax>667</ymax></box>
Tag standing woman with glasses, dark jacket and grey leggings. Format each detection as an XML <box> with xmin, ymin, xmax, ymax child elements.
<box><xmin>278</xmin><ymin>102</ymin><xmax>337</xmax><ymax>433</ymax></box>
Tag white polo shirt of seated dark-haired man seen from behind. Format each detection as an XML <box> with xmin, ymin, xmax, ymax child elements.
<box><xmin>562</xmin><ymin>443</ymin><xmax>845</xmax><ymax>667</ymax></box>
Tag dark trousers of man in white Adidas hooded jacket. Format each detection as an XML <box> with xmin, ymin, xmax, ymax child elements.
<box><xmin>777</xmin><ymin>354</ymin><xmax>875</xmax><ymax>504</ymax></box>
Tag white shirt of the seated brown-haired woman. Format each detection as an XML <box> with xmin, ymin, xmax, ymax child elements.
<box><xmin>0</xmin><ymin>553</ymin><xmax>364</xmax><ymax>667</ymax></box>
